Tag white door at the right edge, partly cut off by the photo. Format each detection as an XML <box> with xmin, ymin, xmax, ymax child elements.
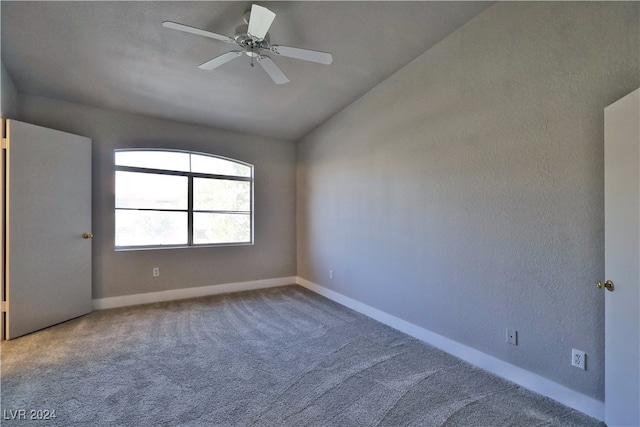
<box><xmin>604</xmin><ymin>89</ymin><xmax>640</xmax><ymax>427</ymax></box>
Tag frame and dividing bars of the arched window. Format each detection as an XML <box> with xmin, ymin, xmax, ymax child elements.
<box><xmin>113</xmin><ymin>148</ymin><xmax>254</xmax><ymax>251</ymax></box>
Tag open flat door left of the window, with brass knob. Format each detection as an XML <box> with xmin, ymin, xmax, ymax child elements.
<box><xmin>5</xmin><ymin>120</ymin><xmax>92</xmax><ymax>339</ymax></box>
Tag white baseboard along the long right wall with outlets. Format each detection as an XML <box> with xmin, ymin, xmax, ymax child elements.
<box><xmin>296</xmin><ymin>277</ymin><xmax>604</xmax><ymax>421</ymax></box>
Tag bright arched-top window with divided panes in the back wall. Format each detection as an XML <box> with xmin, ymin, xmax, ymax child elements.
<box><xmin>115</xmin><ymin>149</ymin><xmax>253</xmax><ymax>249</ymax></box>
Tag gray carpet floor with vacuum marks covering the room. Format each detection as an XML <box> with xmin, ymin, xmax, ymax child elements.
<box><xmin>0</xmin><ymin>286</ymin><xmax>604</xmax><ymax>426</ymax></box>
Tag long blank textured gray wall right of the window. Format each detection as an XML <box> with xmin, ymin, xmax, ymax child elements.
<box><xmin>297</xmin><ymin>2</ymin><xmax>640</xmax><ymax>400</ymax></box>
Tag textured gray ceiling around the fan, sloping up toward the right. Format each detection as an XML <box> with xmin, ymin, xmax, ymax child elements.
<box><xmin>1</xmin><ymin>1</ymin><xmax>491</xmax><ymax>140</ymax></box>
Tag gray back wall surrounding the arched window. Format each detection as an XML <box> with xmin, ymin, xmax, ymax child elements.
<box><xmin>19</xmin><ymin>95</ymin><xmax>296</xmax><ymax>298</ymax></box>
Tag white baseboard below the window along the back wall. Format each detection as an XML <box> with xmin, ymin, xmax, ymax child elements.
<box><xmin>93</xmin><ymin>277</ymin><xmax>296</xmax><ymax>310</ymax></box>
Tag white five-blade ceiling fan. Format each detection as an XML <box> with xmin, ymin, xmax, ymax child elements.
<box><xmin>162</xmin><ymin>4</ymin><xmax>333</xmax><ymax>84</ymax></box>
